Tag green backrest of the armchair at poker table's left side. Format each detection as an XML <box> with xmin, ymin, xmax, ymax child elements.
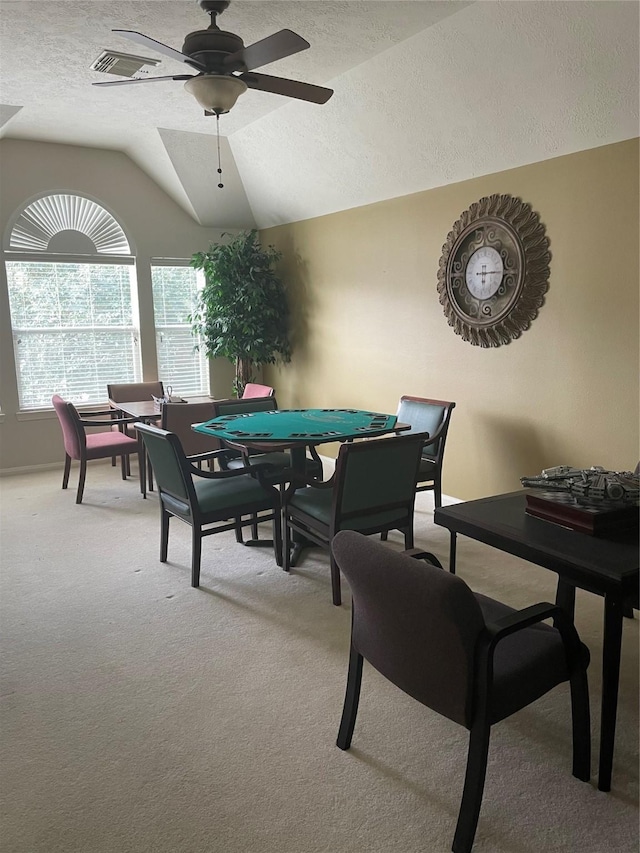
<box><xmin>136</xmin><ymin>422</ymin><xmax>197</xmax><ymax>515</ymax></box>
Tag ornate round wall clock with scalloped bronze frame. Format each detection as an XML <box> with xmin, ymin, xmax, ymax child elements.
<box><xmin>438</xmin><ymin>195</ymin><xmax>551</xmax><ymax>347</ymax></box>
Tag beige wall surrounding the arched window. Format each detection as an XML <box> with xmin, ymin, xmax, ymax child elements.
<box><xmin>0</xmin><ymin>139</ymin><xmax>233</xmax><ymax>471</ymax></box>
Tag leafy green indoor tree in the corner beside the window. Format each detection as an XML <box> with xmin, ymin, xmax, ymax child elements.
<box><xmin>189</xmin><ymin>230</ymin><xmax>291</xmax><ymax>397</ymax></box>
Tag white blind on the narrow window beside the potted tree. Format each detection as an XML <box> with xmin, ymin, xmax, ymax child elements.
<box><xmin>151</xmin><ymin>262</ymin><xmax>209</xmax><ymax>396</ymax></box>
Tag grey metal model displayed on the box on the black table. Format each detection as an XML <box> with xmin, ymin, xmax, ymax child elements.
<box><xmin>520</xmin><ymin>465</ymin><xmax>640</xmax><ymax>507</ymax></box>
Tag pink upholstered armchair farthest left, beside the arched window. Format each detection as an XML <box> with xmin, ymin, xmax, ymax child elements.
<box><xmin>52</xmin><ymin>394</ymin><xmax>145</xmax><ymax>504</ymax></box>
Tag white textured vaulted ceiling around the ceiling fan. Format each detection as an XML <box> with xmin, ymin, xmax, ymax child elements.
<box><xmin>0</xmin><ymin>0</ymin><xmax>640</xmax><ymax>227</ymax></box>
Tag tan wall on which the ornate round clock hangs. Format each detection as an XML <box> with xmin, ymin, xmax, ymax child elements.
<box><xmin>263</xmin><ymin>140</ymin><xmax>640</xmax><ymax>499</ymax></box>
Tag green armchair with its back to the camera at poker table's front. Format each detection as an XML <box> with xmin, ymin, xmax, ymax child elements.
<box><xmin>282</xmin><ymin>433</ymin><xmax>426</xmax><ymax>605</ymax></box>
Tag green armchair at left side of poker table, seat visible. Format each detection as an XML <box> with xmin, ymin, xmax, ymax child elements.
<box><xmin>136</xmin><ymin>423</ymin><xmax>282</xmax><ymax>587</ymax></box>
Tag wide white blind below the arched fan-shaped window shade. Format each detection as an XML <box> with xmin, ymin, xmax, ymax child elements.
<box><xmin>6</xmin><ymin>261</ymin><xmax>142</xmax><ymax>409</ymax></box>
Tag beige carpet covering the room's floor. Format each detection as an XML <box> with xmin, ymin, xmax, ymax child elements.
<box><xmin>0</xmin><ymin>464</ymin><xmax>638</xmax><ymax>853</ymax></box>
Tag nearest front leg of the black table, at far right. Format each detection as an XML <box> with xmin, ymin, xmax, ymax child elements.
<box><xmin>598</xmin><ymin>596</ymin><xmax>623</xmax><ymax>791</ymax></box>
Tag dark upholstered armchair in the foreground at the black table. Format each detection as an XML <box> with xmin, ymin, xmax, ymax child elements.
<box><xmin>332</xmin><ymin>531</ymin><xmax>591</xmax><ymax>853</ymax></box>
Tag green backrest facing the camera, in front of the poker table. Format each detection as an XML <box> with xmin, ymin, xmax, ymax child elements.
<box><xmin>332</xmin><ymin>433</ymin><xmax>425</xmax><ymax>530</ymax></box>
